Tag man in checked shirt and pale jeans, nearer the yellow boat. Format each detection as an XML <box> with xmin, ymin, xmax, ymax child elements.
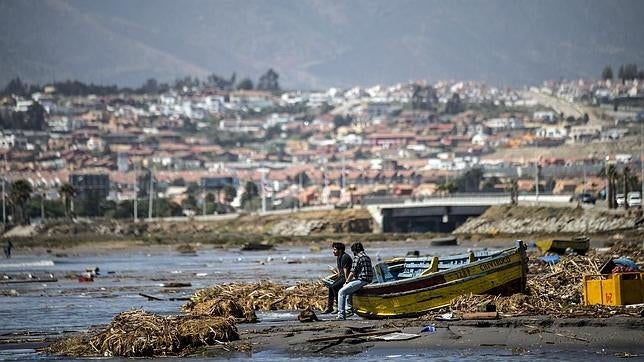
<box><xmin>337</xmin><ymin>242</ymin><xmax>373</xmax><ymax>319</ymax></box>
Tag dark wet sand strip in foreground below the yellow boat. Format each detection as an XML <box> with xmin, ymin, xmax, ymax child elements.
<box><xmin>226</xmin><ymin>315</ymin><xmax>644</xmax><ymax>358</ymax></box>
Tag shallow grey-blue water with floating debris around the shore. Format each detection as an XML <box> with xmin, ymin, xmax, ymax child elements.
<box><xmin>0</xmin><ymin>242</ymin><xmax>632</xmax><ymax>361</ymax></box>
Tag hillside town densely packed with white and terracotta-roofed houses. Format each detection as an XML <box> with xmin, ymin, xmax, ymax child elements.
<box><xmin>0</xmin><ymin>72</ymin><xmax>642</xmax><ymax>229</ymax></box>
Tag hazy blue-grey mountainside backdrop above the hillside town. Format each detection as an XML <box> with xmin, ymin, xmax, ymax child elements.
<box><xmin>0</xmin><ymin>0</ymin><xmax>644</xmax><ymax>88</ymax></box>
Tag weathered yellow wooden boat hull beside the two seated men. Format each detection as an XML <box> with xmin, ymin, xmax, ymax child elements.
<box><xmin>353</xmin><ymin>241</ymin><xmax>528</xmax><ymax>319</ymax></box>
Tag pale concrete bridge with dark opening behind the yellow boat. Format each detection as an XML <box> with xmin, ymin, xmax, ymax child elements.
<box><xmin>365</xmin><ymin>194</ymin><xmax>576</xmax><ymax>233</ymax></box>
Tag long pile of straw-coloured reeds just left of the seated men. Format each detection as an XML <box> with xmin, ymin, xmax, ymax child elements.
<box><xmin>182</xmin><ymin>281</ymin><xmax>327</xmax><ymax>313</ymax></box>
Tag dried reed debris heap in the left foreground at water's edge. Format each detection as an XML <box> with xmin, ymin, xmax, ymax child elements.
<box><xmin>46</xmin><ymin>310</ymin><xmax>239</xmax><ymax>357</ymax></box>
